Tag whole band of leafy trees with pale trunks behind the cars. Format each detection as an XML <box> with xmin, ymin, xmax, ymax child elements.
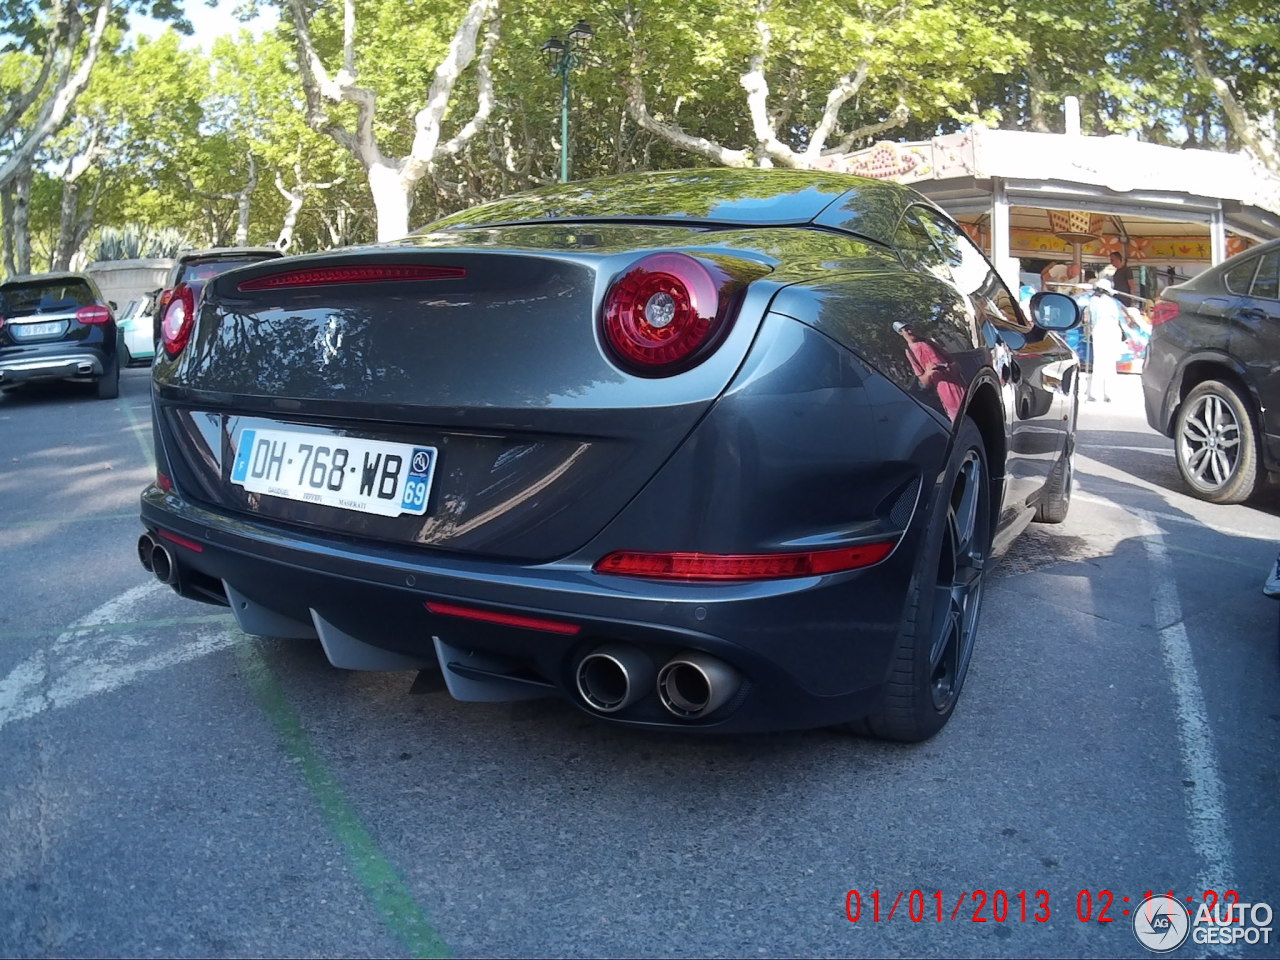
<box><xmin>0</xmin><ymin>0</ymin><xmax>1280</xmax><ymax>273</ymax></box>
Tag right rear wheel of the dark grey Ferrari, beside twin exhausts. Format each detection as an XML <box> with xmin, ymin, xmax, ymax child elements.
<box><xmin>850</xmin><ymin>417</ymin><xmax>992</xmax><ymax>742</ymax></box>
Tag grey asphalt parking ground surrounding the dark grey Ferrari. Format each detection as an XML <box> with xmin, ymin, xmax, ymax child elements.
<box><xmin>0</xmin><ymin>370</ymin><xmax>1280</xmax><ymax>957</ymax></box>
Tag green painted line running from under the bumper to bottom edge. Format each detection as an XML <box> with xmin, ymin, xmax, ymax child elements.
<box><xmin>236</xmin><ymin>636</ymin><xmax>451</xmax><ymax>957</ymax></box>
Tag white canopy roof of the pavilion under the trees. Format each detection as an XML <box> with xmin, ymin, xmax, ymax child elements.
<box><xmin>820</xmin><ymin>127</ymin><xmax>1280</xmax><ymax>276</ymax></box>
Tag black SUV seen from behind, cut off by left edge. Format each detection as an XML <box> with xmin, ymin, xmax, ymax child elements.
<box><xmin>0</xmin><ymin>273</ymin><xmax>120</xmax><ymax>399</ymax></box>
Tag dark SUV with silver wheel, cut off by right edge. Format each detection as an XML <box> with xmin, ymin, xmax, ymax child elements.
<box><xmin>1142</xmin><ymin>241</ymin><xmax>1280</xmax><ymax>503</ymax></box>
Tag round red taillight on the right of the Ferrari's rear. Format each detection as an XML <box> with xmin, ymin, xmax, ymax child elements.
<box><xmin>604</xmin><ymin>253</ymin><xmax>728</xmax><ymax>376</ymax></box>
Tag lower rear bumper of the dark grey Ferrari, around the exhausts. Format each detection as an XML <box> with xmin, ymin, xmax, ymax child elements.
<box><xmin>142</xmin><ymin>486</ymin><xmax>914</xmax><ymax>732</ymax></box>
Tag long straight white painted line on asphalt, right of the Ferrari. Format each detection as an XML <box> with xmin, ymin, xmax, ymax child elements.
<box><xmin>1134</xmin><ymin>511</ymin><xmax>1234</xmax><ymax>891</ymax></box>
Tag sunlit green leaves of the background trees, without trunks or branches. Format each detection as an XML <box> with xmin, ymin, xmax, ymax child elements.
<box><xmin>0</xmin><ymin>0</ymin><xmax>1280</xmax><ymax>259</ymax></box>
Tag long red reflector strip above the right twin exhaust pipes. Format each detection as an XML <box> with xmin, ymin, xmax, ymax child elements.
<box><xmin>595</xmin><ymin>540</ymin><xmax>895</xmax><ymax>580</ymax></box>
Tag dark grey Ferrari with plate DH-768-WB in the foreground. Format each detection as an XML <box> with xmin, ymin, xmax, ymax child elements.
<box><xmin>138</xmin><ymin>170</ymin><xmax>1078</xmax><ymax>741</ymax></box>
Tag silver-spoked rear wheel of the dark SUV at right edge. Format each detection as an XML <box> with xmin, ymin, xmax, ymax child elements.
<box><xmin>1174</xmin><ymin>380</ymin><xmax>1258</xmax><ymax>503</ymax></box>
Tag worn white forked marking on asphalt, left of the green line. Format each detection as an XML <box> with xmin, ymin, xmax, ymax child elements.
<box><xmin>0</xmin><ymin>580</ymin><xmax>237</xmax><ymax>730</ymax></box>
